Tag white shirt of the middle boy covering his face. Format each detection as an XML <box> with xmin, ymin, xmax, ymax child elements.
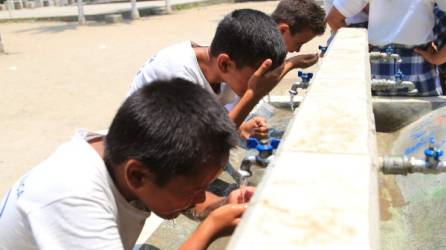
<box><xmin>128</xmin><ymin>41</ymin><xmax>238</xmax><ymax>108</ymax></box>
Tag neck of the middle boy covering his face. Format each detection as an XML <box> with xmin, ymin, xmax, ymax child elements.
<box><xmin>193</xmin><ymin>47</ymin><xmax>223</xmax><ymax>88</ymax></box>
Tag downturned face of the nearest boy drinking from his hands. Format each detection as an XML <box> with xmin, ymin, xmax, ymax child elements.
<box><xmin>139</xmin><ymin>158</ymin><xmax>227</xmax><ymax>219</ymax></box>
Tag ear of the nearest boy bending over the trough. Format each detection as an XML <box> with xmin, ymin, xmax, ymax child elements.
<box><xmin>124</xmin><ymin>159</ymin><xmax>153</xmax><ymax>189</ymax></box>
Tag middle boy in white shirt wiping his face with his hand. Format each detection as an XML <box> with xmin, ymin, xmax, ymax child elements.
<box><xmin>129</xmin><ymin>9</ymin><xmax>286</xmax><ymax>137</ymax></box>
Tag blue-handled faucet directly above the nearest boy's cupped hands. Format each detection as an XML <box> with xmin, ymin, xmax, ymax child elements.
<box><xmin>240</xmin><ymin>137</ymin><xmax>280</xmax><ymax>180</ymax></box>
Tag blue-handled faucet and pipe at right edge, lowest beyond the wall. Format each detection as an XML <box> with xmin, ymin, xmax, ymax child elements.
<box><xmin>380</xmin><ymin>140</ymin><xmax>446</xmax><ymax>175</ymax></box>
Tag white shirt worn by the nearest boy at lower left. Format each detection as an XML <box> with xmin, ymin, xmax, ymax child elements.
<box><xmin>0</xmin><ymin>130</ymin><xmax>150</xmax><ymax>250</ymax></box>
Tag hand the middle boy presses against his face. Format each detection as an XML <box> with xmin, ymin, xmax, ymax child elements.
<box><xmin>248</xmin><ymin>59</ymin><xmax>284</xmax><ymax>98</ymax></box>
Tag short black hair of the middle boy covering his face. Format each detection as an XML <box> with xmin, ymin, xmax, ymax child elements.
<box><xmin>210</xmin><ymin>9</ymin><xmax>287</xmax><ymax>69</ymax></box>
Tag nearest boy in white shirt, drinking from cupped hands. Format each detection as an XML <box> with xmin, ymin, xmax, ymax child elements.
<box><xmin>0</xmin><ymin>79</ymin><xmax>252</xmax><ymax>250</ymax></box>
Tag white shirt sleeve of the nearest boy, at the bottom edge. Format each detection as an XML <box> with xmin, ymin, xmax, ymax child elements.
<box><xmin>28</xmin><ymin>198</ymin><xmax>124</xmax><ymax>249</ymax></box>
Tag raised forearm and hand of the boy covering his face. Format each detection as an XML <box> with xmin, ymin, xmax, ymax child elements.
<box><xmin>229</xmin><ymin>59</ymin><xmax>283</xmax><ymax>128</ymax></box>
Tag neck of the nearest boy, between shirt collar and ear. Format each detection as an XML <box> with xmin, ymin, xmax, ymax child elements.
<box><xmin>88</xmin><ymin>140</ymin><xmax>136</xmax><ymax>201</ymax></box>
